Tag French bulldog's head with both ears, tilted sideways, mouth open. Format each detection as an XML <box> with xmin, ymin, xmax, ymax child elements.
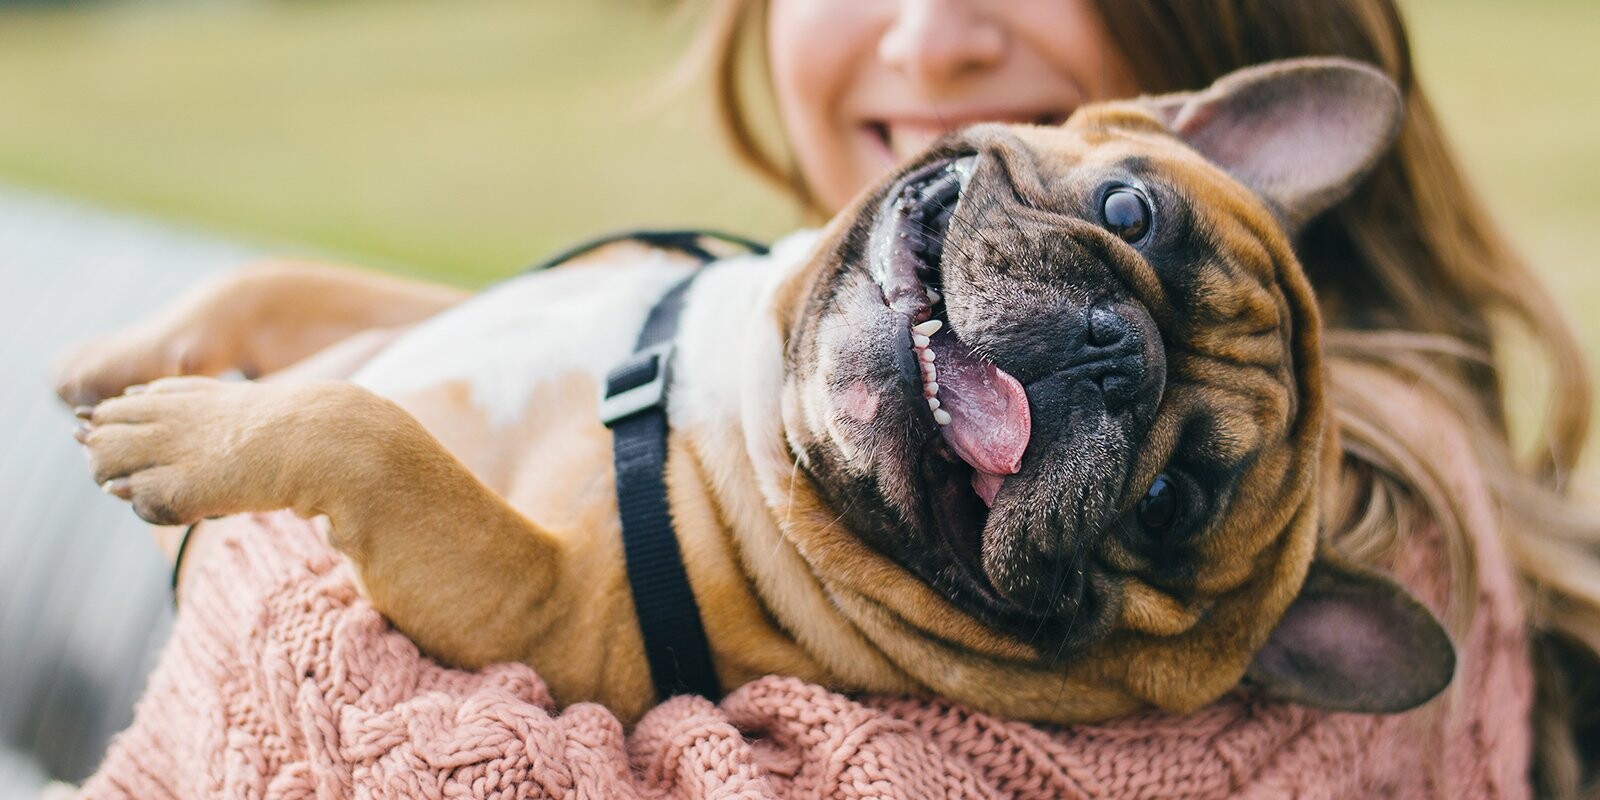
<box><xmin>768</xmin><ymin>59</ymin><xmax>1454</xmax><ymax>720</ymax></box>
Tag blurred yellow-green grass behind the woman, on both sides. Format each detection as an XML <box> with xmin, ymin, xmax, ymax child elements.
<box><xmin>0</xmin><ymin>0</ymin><xmax>1600</xmax><ymax>470</ymax></box>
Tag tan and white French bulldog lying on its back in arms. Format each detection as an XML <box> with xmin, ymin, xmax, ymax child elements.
<box><xmin>59</xmin><ymin>59</ymin><xmax>1454</xmax><ymax>723</ymax></box>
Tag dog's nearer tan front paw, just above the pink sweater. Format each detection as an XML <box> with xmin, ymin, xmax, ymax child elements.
<box><xmin>75</xmin><ymin>378</ymin><xmax>278</xmax><ymax>525</ymax></box>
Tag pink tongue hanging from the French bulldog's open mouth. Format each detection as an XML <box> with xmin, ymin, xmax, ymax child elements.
<box><xmin>928</xmin><ymin>328</ymin><xmax>1034</xmax><ymax>506</ymax></box>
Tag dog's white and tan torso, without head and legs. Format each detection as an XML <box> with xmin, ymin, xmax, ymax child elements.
<box><xmin>342</xmin><ymin>235</ymin><xmax>902</xmax><ymax>714</ymax></box>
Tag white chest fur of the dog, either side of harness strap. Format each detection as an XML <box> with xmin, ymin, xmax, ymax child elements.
<box><xmin>342</xmin><ymin>235</ymin><xmax>810</xmax><ymax>499</ymax></box>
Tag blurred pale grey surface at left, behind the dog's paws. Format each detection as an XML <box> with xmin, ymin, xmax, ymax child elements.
<box><xmin>0</xmin><ymin>189</ymin><xmax>262</xmax><ymax>797</ymax></box>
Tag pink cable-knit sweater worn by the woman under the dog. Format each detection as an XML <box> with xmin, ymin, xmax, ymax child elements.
<box><xmin>85</xmin><ymin>390</ymin><xmax>1531</xmax><ymax>800</ymax></box>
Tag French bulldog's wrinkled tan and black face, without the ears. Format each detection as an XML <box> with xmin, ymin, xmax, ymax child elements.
<box><xmin>780</xmin><ymin>120</ymin><xmax>1322</xmax><ymax>656</ymax></box>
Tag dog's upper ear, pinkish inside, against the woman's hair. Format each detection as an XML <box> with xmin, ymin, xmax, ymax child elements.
<box><xmin>1144</xmin><ymin>58</ymin><xmax>1405</xmax><ymax>232</ymax></box>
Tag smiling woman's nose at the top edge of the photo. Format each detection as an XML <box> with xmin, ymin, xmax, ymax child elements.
<box><xmin>878</xmin><ymin>0</ymin><xmax>1014</xmax><ymax>88</ymax></box>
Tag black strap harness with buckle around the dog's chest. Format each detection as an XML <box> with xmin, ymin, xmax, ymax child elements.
<box><xmin>533</xmin><ymin>230</ymin><xmax>766</xmax><ymax>699</ymax></box>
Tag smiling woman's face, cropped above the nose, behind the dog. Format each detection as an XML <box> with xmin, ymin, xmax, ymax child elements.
<box><xmin>766</xmin><ymin>0</ymin><xmax>1136</xmax><ymax>210</ymax></box>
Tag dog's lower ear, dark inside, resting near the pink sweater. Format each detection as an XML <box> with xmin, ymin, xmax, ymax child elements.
<box><xmin>1245</xmin><ymin>557</ymin><xmax>1456</xmax><ymax>714</ymax></box>
